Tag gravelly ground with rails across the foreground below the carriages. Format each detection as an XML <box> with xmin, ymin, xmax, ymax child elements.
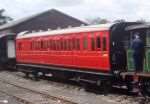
<box><xmin>0</xmin><ymin>72</ymin><xmax>150</xmax><ymax>104</ymax></box>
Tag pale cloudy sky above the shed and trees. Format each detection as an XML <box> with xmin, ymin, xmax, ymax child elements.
<box><xmin>0</xmin><ymin>0</ymin><xmax>150</xmax><ymax>21</ymax></box>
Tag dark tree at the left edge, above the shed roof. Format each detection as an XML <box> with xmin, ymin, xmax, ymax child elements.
<box><xmin>0</xmin><ymin>9</ymin><xmax>13</xmax><ymax>25</ymax></box>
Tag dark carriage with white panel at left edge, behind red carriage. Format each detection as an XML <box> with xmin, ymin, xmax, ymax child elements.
<box><xmin>0</xmin><ymin>33</ymin><xmax>16</xmax><ymax>68</ymax></box>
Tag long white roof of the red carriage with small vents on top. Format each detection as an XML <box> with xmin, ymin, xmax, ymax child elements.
<box><xmin>17</xmin><ymin>23</ymin><xmax>114</xmax><ymax>39</ymax></box>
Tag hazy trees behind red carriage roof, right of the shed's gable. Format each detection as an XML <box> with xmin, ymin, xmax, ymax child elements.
<box><xmin>86</xmin><ymin>17</ymin><xmax>110</xmax><ymax>25</ymax></box>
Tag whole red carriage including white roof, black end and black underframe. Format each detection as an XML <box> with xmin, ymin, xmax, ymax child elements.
<box><xmin>16</xmin><ymin>22</ymin><xmax>137</xmax><ymax>83</ymax></box>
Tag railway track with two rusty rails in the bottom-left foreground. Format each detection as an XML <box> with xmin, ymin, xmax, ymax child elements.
<box><xmin>0</xmin><ymin>79</ymin><xmax>76</xmax><ymax>104</ymax></box>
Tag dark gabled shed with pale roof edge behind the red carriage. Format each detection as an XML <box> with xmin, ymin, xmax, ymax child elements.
<box><xmin>0</xmin><ymin>9</ymin><xmax>87</xmax><ymax>33</ymax></box>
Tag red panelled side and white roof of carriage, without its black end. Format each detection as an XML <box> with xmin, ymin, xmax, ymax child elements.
<box><xmin>16</xmin><ymin>25</ymin><xmax>111</xmax><ymax>72</ymax></box>
